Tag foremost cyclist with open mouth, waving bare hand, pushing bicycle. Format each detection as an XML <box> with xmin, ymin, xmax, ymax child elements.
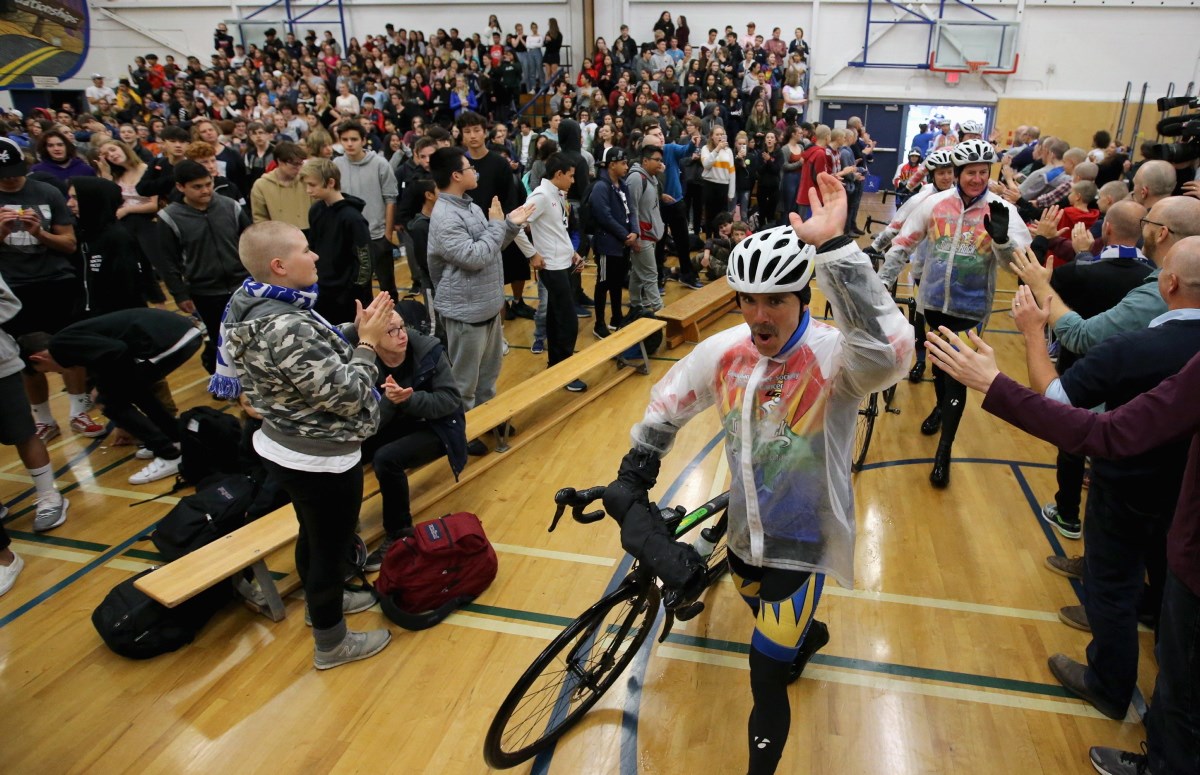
<box><xmin>605</xmin><ymin>173</ymin><xmax>913</xmax><ymax>775</ymax></box>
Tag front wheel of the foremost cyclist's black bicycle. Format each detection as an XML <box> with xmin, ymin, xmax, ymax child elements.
<box><xmin>484</xmin><ymin>582</ymin><xmax>660</xmax><ymax>769</ymax></box>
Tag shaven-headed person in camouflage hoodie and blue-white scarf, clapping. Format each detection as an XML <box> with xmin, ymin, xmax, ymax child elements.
<box><xmin>210</xmin><ymin>221</ymin><xmax>394</xmax><ymax>669</ymax></box>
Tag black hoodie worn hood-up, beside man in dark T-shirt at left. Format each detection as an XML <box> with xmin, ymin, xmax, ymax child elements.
<box><xmin>71</xmin><ymin>176</ymin><xmax>146</xmax><ymax>316</ymax></box>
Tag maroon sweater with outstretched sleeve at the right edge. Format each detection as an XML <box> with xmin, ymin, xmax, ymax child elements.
<box><xmin>983</xmin><ymin>355</ymin><xmax>1200</xmax><ymax>596</ymax></box>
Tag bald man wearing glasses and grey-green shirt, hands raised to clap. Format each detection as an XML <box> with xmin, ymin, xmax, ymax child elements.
<box><xmin>1013</xmin><ymin>195</ymin><xmax>1200</xmax><ymax>354</ymax></box>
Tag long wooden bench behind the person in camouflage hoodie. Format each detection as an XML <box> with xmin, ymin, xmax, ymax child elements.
<box><xmin>134</xmin><ymin>318</ymin><xmax>666</xmax><ymax>621</ymax></box>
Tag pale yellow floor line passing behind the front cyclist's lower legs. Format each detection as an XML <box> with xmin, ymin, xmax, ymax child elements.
<box><xmin>655</xmin><ymin>645</ymin><xmax>1106</xmax><ymax>719</ymax></box>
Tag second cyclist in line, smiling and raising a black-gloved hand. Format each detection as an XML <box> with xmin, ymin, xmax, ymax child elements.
<box><xmin>880</xmin><ymin>140</ymin><xmax>1031</xmax><ymax>487</ymax></box>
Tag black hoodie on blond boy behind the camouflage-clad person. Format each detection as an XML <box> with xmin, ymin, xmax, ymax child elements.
<box><xmin>308</xmin><ymin>194</ymin><xmax>371</xmax><ymax>301</ymax></box>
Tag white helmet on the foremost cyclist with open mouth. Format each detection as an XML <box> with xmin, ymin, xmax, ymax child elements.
<box><xmin>727</xmin><ymin>226</ymin><xmax>817</xmax><ymax>293</ymax></box>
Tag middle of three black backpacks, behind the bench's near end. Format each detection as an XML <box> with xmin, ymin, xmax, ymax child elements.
<box><xmin>150</xmin><ymin>474</ymin><xmax>258</xmax><ymax>563</ymax></box>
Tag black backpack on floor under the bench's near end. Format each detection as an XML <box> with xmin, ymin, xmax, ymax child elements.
<box><xmin>91</xmin><ymin>569</ymin><xmax>233</xmax><ymax>660</ymax></box>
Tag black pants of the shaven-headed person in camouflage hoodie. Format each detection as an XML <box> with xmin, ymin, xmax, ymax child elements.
<box><xmin>263</xmin><ymin>461</ymin><xmax>362</xmax><ymax>630</ymax></box>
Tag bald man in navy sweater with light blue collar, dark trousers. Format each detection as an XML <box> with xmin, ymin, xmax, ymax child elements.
<box><xmin>1013</xmin><ymin>233</ymin><xmax>1200</xmax><ymax>720</ymax></box>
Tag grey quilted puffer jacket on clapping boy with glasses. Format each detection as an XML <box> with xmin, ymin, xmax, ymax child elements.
<box><xmin>428</xmin><ymin>193</ymin><xmax>518</xmax><ymax>323</ymax></box>
